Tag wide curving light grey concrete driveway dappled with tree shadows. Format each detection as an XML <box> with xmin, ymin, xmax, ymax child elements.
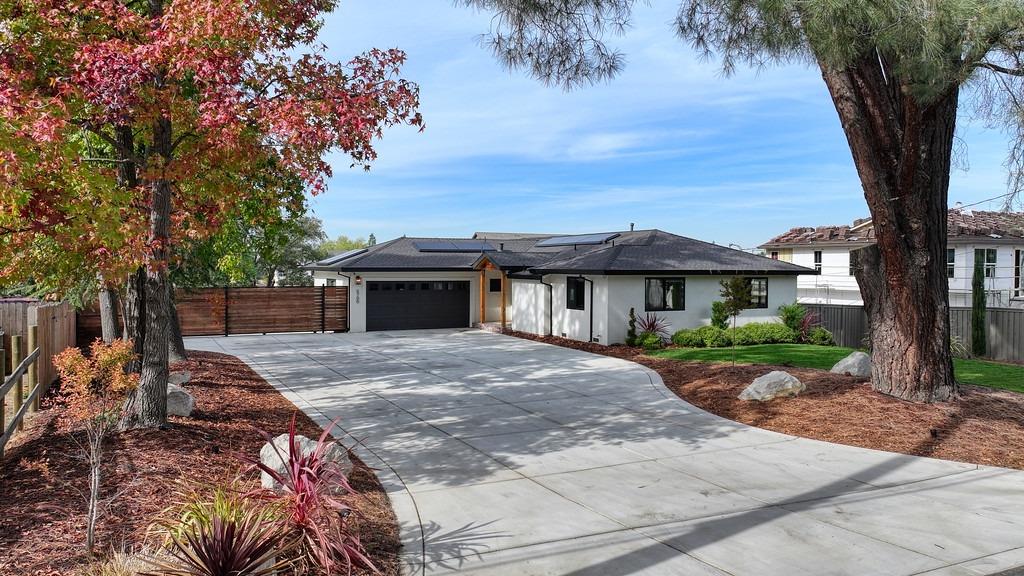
<box><xmin>187</xmin><ymin>330</ymin><xmax>1024</xmax><ymax>576</ymax></box>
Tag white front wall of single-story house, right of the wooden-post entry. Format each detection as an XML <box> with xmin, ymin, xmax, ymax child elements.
<box><xmin>511</xmin><ymin>275</ymin><xmax>797</xmax><ymax>344</ymax></box>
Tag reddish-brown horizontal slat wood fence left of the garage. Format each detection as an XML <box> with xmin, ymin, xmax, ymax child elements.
<box><xmin>78</xmin><ymin>286</ymin><xmax>348</xmax><ymax>345</ymax></box>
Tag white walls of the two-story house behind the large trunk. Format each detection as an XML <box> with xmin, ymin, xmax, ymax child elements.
<box><xmin>793</xmin><ymin>242</ymin><xmax>1024</xmax><ymax>307</ymax></box>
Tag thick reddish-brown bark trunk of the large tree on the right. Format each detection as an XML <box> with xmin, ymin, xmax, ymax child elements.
<box><xmin>822</xmin><ymin>52</ymin><xmax>958</xmax><ymax>402</ymax></box>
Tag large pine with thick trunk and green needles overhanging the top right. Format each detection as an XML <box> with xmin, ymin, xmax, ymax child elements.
<box><xmin>461</xmin><ymin>0</ymin><xmax>1024</xmax><ymax>402</ymax></box>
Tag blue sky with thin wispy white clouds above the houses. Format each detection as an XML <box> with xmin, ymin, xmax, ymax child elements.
<box><xmin>312</xmin><ymin>0</ymin><xmax>1007</xmax><ymax>248</ymax></box>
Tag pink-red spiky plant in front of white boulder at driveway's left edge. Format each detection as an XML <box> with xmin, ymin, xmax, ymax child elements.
<box><xmin>247</xmin><ymin>415</ymin><xmax>379</xmax><ymax>575</ymax></box>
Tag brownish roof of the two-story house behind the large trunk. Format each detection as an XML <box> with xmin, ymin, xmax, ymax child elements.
<box><xmin>760</xmin><ymin>208</ymin><xmax>1024</xmax><ymax>248</ymax></box>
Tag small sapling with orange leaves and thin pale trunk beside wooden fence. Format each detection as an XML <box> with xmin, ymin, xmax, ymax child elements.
<box><xmin>53</xmin><ymin>339</ymin><xmax>138</xmax><ymax>553</ymax></box>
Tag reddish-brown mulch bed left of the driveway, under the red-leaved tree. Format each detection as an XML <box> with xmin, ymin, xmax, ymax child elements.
<box><xmin>0</xmin><ymin>352</ymin><xmax>400</xmax><ymax>576</ymax></box>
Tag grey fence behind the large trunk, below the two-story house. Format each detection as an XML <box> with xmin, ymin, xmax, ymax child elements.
<box><xmin>804</xmin><ymin>304</ymin><xmax>1024</xmax><ymax>362</ymax></box>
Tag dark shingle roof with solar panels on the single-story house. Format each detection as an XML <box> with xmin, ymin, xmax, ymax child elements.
<box><xmin>306</xmin><ymin>230</ymin><xmax>815</xmax><ymax>275</ymax></box>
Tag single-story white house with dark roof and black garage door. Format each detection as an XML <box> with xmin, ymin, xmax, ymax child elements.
<box><xmin>299</xmin><ymin>230</ymin><xmax>813</xmax><ymax>343</ymax></box>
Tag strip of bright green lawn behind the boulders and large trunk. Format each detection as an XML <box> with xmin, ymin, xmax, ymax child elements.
<box><xmin>653</xmin><ymin>344</ymin><xmax>1024</xmax><ymax>393</ymax></box>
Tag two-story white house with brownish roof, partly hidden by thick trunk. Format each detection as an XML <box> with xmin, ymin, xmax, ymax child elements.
<box><xmin>761</xmin><ymin>208</ymin><xmax>1024</xmax><ymax>307</ymax></box>
